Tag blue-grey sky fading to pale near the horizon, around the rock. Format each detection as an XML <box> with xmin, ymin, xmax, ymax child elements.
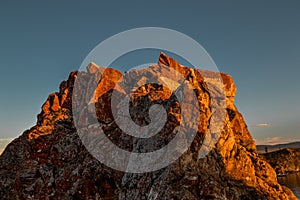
<box><xmin>0</xmin><ymin>0</ymin><xmax>300</xmax><ymax>143</ymax></box>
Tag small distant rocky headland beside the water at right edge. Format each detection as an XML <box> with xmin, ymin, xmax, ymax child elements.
<box><xmin>261</xmin><ymin>148</ymin><xmax>300</xmax><ymax>174</ymax></box>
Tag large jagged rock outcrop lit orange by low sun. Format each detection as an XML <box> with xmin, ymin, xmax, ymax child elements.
<box><xmin>0</xmin><ymin>54</ymin><xmax>296</xmax><ymax>200</ymax></box>
